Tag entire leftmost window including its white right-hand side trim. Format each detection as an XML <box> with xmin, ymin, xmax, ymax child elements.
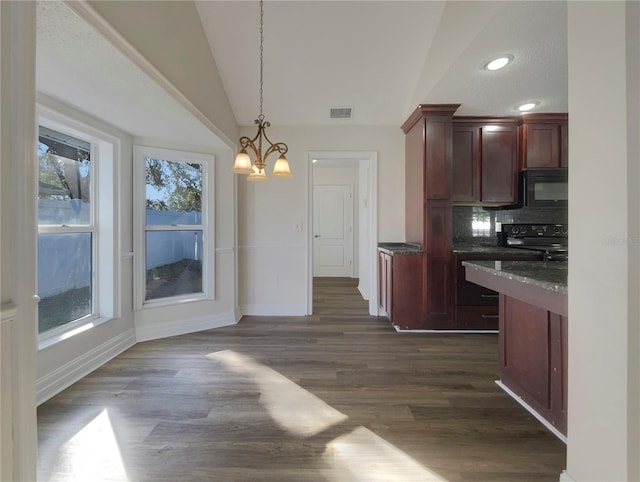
<box><xmin>37</xmin><ymin>107</ymin><xmax>119</xmax><ymax>346</ymax></box>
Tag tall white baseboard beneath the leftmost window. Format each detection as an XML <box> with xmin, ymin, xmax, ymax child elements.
<box><xmin>36</xmin><ymin>328</ymin><xmax>136</xmax><ymax>405</ymax></box>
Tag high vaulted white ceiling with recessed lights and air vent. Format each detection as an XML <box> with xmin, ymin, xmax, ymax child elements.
<box><xmin>196</xmin><ymin>0</ymin><xmax>567</xmax><ymax>126</ymax></box>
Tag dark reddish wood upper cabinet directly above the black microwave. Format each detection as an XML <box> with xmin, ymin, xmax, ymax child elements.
<box><xmin>520</xmin><ymin>114</ymin><xmax>568</xmax><ymax>169</ymax></box>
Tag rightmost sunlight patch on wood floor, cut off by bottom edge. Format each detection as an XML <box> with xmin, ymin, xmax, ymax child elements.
<box><xmin>322</xmin><ymin>427</ymin><xmax>447</xmax><ymax>482</ymax></box>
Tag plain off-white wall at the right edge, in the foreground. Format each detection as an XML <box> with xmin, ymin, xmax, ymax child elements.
<box><xmin>564</xmin><ymin>2</ymin><xmax>640</xmax><ymax>481</ymax></box>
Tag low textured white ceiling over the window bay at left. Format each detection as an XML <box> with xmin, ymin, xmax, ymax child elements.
<box><xmin>36</xmin><ymin>1</ymin><xmax>225</xmax><ymax>147</ymax></box>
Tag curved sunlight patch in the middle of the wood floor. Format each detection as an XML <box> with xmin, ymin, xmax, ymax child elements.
<box><xmin>207</xmin><ymin>350</ymin><xmax>347</xmax><ymax>438</ymax></box>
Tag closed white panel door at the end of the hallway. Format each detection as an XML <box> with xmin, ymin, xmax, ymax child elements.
<box><xmin>313</xmin><ymin>185</ymin><xmax>353</xmax><ymax>278</ymax></box>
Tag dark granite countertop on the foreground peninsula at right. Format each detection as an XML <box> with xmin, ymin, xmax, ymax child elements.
<box><xmin>462</xmin><ymin>261</ymin><xmax>568</xmax><ymax>294</ymax></box>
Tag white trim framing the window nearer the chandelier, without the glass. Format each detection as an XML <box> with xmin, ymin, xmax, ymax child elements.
<box><xmin>133</xmin><ymin>145</ymin><xmax>215</xmax><ymax>310</ymax></box>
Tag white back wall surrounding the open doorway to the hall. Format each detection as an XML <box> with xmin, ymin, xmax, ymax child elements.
<box><xmin>238</xmin><ymin>125</ymin><xmax>404</xmax><ymax>315</ymax></box>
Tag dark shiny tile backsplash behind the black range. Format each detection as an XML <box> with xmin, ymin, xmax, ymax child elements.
<box><xmin>453</xmin><ymin>206</ymin><xmax>568</xmax><ymax>246</ymax></box>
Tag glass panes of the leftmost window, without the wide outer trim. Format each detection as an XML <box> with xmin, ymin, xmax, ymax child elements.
<box><xmin>38</xmin><ymin>126</ymin><xmax>95</xmax><ymax>333</ymax></box>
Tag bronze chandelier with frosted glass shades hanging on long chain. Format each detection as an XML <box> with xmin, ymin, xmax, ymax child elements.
<box><xmin>231</xmin><ymin>0</ymin><xmax>293</xmax><ymax>181</ymax></box>
